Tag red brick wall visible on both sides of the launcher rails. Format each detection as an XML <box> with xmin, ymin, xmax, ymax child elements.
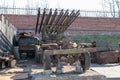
<box><xmin>1</xmin><ymin>15</ymin><xmax>120</xmax><ymax>34</ymax></box>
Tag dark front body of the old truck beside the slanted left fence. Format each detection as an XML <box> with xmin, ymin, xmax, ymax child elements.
<box><xmin>15</xmin><ymin>32</ymin><xmax>39</xmax><ymax>59</ymax></box>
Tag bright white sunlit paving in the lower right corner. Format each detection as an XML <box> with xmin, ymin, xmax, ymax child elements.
<box><xmin>91</xmin><ymin>63</ymin><xmax>120</xmax><ymax>80</ymax></box>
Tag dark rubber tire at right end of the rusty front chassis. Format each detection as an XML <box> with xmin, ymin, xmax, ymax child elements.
<box><xmin>79</xmin><ymin>53</ymin><xmax>91</xmax><ymax>72</ymax></box>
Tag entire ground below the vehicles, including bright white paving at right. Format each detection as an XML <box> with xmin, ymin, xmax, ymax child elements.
<box><xmin>0</xmin><ymin>60</ymin><xmax>120</xmax><ymax>80</ymax></box>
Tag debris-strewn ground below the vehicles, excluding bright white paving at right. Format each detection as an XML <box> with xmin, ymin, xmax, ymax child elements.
<box><xmin>0</xmin><ymin>60</ymin><xmax>106</xmax><ymax>80</ymax></box>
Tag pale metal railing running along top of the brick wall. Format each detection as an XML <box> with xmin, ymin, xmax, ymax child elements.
<box><xmin>0</xmin><ymin>7</ymin><xmax>119</xmax><ymax>18</ymax></box>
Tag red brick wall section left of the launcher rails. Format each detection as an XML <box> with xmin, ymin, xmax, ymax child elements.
<box><xmin>1</xmin><ymin>15</ymin><xmax>37</xmax><ymax>29</ymax></box>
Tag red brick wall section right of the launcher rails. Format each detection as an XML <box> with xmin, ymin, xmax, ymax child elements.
<box><xmin>71</xmin><ymin>17</ymin><xmax>120</xmax><ymax>30</ymax></box>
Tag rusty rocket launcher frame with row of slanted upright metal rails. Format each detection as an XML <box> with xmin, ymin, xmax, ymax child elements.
<box><xmin>35</xmin><ymin>8</ymin><xmax>80</xmax><ymax>40</ymax></box>
